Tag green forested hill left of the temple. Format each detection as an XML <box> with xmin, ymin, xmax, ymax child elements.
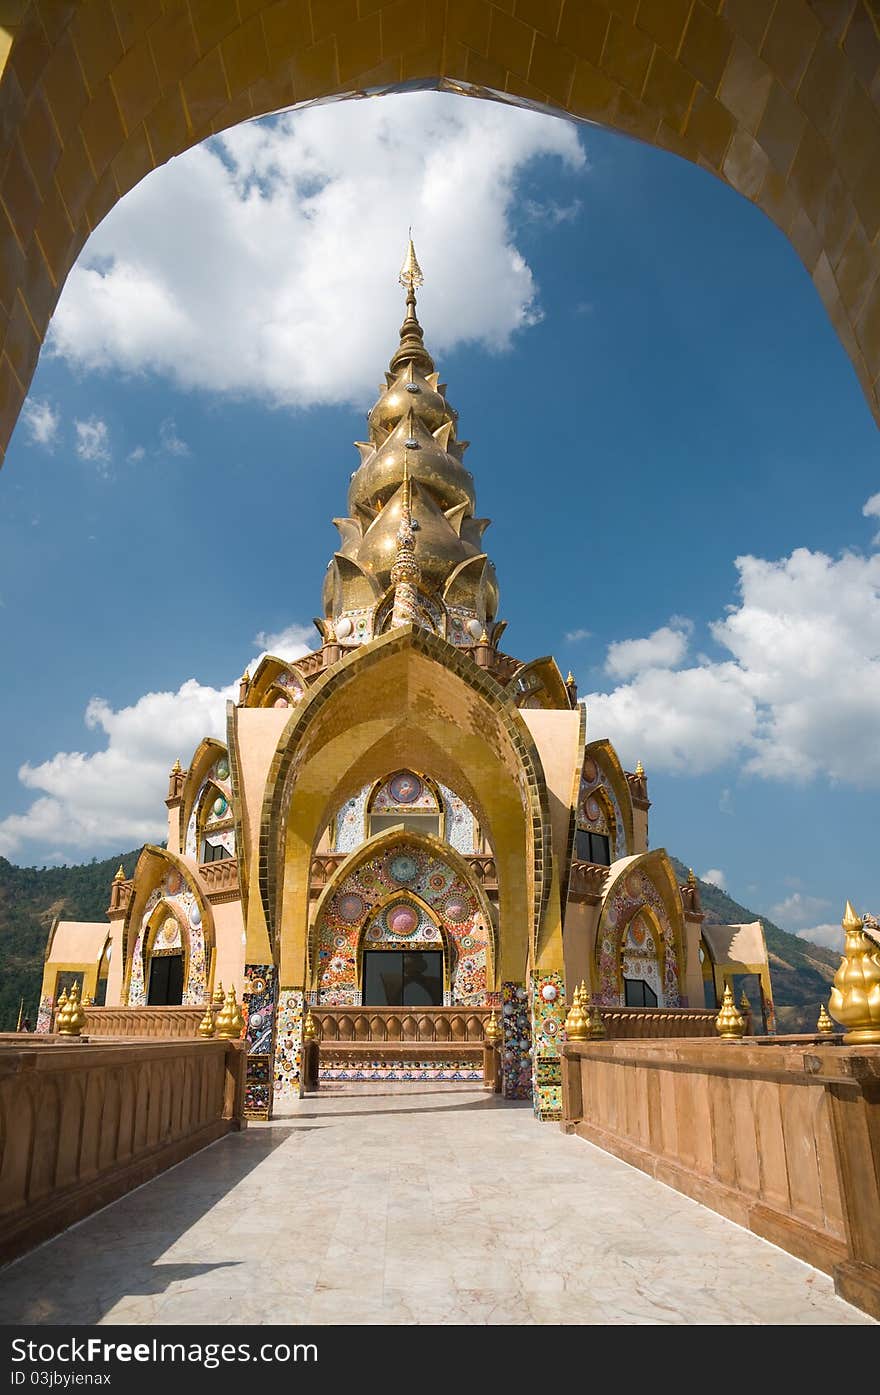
<box><xmin>0</xmin><ymin>848</ymin><xmax>141</xmax><ymax>1032</ymax></box>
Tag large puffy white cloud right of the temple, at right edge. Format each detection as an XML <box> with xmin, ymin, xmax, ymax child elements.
<box><xmin>584</xmin><ymin>548</ymin><xmax>880</xmax><ymax>787</ymax></box>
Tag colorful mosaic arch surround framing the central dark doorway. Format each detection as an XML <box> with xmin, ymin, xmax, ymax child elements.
<box><xmin>314</xmin><ymin>840</ymin><xmax>488</xmax><ymax>1007</ymax></box>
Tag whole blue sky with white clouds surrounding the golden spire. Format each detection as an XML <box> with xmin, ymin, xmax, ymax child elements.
<box><xmin>0</xmin><ymin>95</ymin><xmax>880</xmax><ymax>954</ymax></box>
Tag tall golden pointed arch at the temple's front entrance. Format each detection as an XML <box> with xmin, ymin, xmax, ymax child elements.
<box><xmin>258</xmin><ymin>625</ymin><xmax>562</xmax><ymax>982</ymax></box>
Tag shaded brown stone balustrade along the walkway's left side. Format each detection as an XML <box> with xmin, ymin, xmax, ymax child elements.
<box><xmin>0</xmin><ymin>1036</ymin><xmax>245</xmax><ymax>1261</ymax></box>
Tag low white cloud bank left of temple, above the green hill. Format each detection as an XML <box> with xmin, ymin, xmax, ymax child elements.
<box><xmin>0</xmin><ymin>625</ymin><xmax>314</xmax><ymax>861</ymax></box>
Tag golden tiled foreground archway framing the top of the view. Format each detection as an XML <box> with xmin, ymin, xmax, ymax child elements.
<box><xmin>0</xmin><ymin>0</ymin><xmax>880</xmax><ymax>468</ymax></box>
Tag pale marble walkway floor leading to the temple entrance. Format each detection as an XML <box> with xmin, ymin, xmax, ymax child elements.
<box><xmin>0</xmin><ymin>1085</ymin><xmax>870</xmax><ymax>1324</ymax></box>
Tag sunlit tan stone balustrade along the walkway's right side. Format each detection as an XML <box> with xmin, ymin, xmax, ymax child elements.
<box><xmin>562</xmin><ymin>1039</ymin><xmax>880</xmax><ymax>1317</ymax></box>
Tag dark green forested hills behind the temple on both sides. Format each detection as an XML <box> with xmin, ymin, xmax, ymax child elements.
<box><xmin>0</xmin><ymin>850</ymin><xmax>840</xmax><ymax>1032</ymax></box>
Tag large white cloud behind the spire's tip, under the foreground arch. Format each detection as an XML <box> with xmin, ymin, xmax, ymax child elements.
<box><xmin>49</xmin><ymin>92</ymin><xmax>586</xmax><ymax>406</ymax></box>
